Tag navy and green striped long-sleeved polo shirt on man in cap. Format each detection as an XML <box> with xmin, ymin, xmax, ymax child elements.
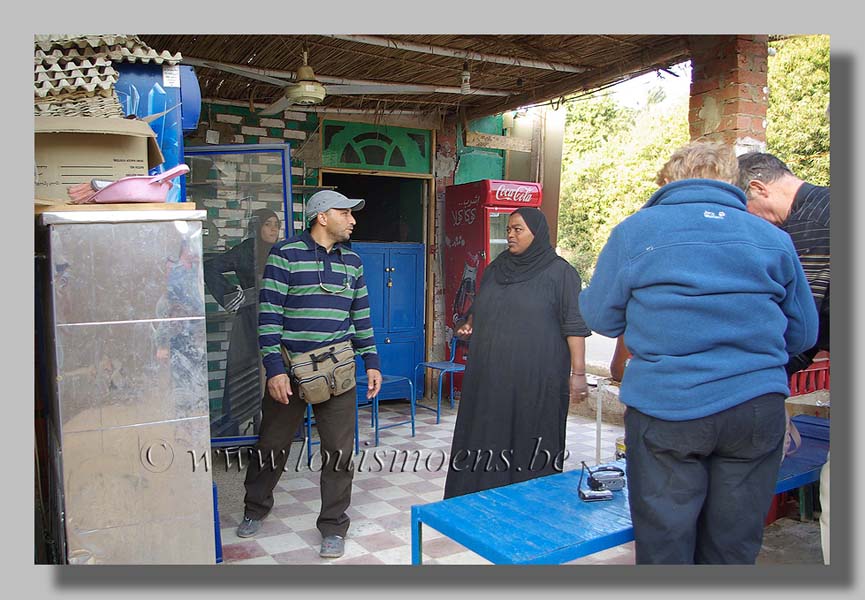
<box><xmin>258</xmin><ymin>230</ymin><xmax>380</xmax><ymax>378</ymax></box>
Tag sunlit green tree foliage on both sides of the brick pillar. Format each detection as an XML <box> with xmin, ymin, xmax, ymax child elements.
<box><xmin>558</xmin><ymin>35</ymin><xmax>829</xmax><ymax>282</ymax></box>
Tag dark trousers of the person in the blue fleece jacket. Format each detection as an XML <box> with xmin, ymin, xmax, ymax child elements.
<box><xmin>625</xmin><ymin>394</ymin><xmax>786</xmax><ymax>564</ymax></box>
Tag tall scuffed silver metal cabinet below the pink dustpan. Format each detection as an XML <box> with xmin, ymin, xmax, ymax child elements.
<box><xmin>37</xmin><ymin>204</ymin><xmax>216</xmax><ymax>564</ymax></box>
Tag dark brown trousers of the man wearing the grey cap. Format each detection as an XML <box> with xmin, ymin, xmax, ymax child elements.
<box><xmin>244</xmin><ymin>386</ymin><xmax>357</xmax><ymax>536</ymax></box>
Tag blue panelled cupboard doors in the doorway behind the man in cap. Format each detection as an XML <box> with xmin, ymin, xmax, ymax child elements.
<box><xmin>352</xmin><ymin>242</ymin><xmax>424</xmax><ymax>400</ymax></box>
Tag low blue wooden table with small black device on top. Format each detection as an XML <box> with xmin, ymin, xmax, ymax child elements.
<box><xmin>411</xmin><ymin>417</ymin><xmax>829</xmax><ymax>565</ymax></box>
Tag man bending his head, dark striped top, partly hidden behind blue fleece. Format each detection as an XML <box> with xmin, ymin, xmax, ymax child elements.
<box><xmin>739</xmin><ymin>152</ymin><xmax>831</xmax><ymax>375</ymax></box>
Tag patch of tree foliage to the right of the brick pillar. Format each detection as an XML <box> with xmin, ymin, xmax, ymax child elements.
<box><xmin>766</xmin><ymin>35</ymin><xmax>829</xmax><ymax>185</ymax></box>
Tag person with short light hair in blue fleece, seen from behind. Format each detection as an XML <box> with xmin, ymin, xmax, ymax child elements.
<box><xmin>579</xmin><ymin>142</ymin><xmax>817</xmax><ymax>564</ymax></box>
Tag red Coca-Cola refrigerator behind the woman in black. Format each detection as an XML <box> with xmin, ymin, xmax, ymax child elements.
<box><xmin>444</xmin><ymin>179</ymin><xmax>541</xmax><ymax>386</ymax></box>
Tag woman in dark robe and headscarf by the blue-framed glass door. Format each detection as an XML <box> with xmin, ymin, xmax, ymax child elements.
<box><xmin>204</xmin><ymin>208</ymin><xmax>279</xmax><ymax>437</ymax></box>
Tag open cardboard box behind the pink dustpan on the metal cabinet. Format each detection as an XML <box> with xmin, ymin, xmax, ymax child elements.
<box><xmin>35</xmin><ymin>117</ymin><xmax>165</xmax><ymax>202</ymax></box>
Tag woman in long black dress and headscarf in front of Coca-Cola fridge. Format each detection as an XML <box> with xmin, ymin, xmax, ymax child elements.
<box><xmin>444</xmin><ymin>208</ymin><xmax>591</xmax><ymax>498</ymax></box>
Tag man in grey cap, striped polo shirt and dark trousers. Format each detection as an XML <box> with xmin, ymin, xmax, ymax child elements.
<box><xmin>237</xmin><ymin>190</ymin><xmax>381</xmax><ymax>558</ymax></box>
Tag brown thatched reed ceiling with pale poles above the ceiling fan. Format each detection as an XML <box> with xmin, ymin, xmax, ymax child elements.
<box><xmin>140</xmin><ymin>34</ymin><xmax>689</xmax><ymax>118</ymax></box>
